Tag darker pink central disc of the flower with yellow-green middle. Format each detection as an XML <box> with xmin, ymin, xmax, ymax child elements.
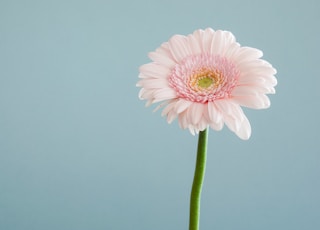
<box><xmin>169</xmin><ymin>53</ymin><xmax>240</xmax><ymax>103</ymax></box>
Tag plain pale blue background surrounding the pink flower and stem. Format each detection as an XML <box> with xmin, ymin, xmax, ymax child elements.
<box><xmin>0</xmin><ymin>0</ymin><xmax>320</xmax><ymax>230</ymax></box>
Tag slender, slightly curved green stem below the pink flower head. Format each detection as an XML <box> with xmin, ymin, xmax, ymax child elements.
<box><xmin>189</xmin><ymin>129</ymin><xmax>208</xmax><ymax>230</ymax></box>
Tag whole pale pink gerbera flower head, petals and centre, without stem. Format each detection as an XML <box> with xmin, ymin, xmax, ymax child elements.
<box><xmin>137</xmin><ymin>28</ymin><xmax>277</xmax><ymax>139</ymax></box>
